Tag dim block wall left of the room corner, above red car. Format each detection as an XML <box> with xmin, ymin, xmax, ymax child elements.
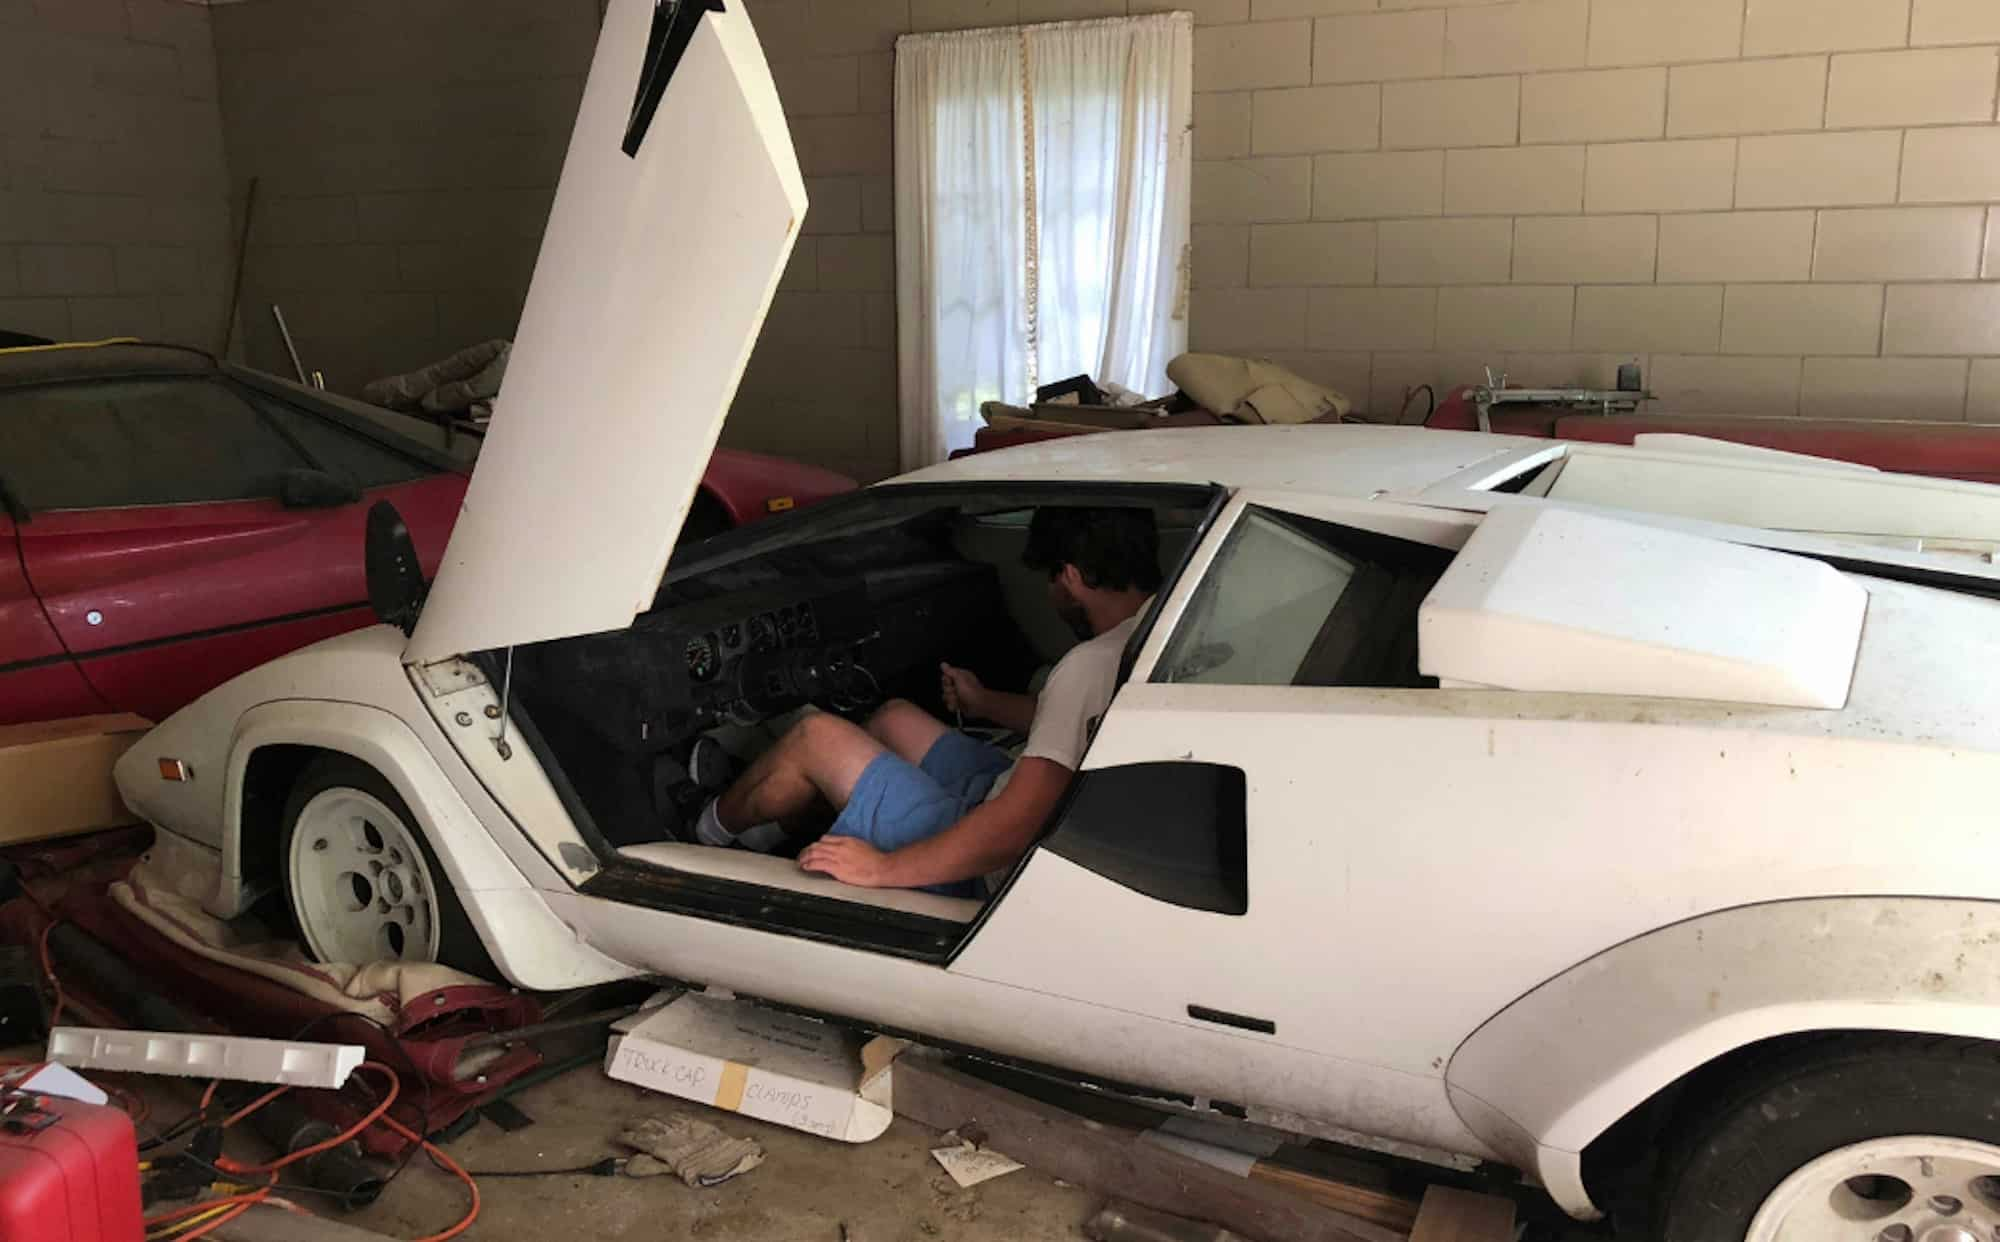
<box><xmin>0</xmin><ymin>0</ymin><xmax>230</xmax><ymax>348</ymax></box>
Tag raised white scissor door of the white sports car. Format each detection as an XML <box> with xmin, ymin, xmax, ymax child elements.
<box><xmin>410</xmin><ymin>0</ymin><xmax>806</xmax><ymax>660</ymax></box>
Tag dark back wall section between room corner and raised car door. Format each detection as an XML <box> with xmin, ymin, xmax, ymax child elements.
<box><xmin>210</xmin><ymin>0</ymin><xmax>598</xmax><ymax>392</ymax></box>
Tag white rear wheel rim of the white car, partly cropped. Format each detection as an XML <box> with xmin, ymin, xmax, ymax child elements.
<box><xmin>1744</xmin><ymin>1134</ymin><xmax>2000</xmax><ymax>1242</ymax></box>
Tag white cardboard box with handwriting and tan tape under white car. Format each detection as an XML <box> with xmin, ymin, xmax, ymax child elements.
<box><xmin>604</xmin><ymin>992</ymin><xmax>904</xmax><ymax>1142</ymax></box>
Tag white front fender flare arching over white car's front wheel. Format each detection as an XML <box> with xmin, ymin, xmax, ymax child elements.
<box><xmin>214</xmin><ymin>700</ymin><xmax>638</xmax><ymax>990</ymax></box>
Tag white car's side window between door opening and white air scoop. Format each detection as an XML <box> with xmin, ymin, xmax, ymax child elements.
<box><xmin>1152</xmin><ymin>508</ymin><xmax>1450</xmax><ymax>686</ymax></box>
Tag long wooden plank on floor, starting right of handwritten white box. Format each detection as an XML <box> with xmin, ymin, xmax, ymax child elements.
<box><xmin>894</xmin><ymin>1052</ymin><xmax>1404</xmax><ymax>1242</ymax></box>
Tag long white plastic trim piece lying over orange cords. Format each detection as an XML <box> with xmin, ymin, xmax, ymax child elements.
<box><xmin>48</xmin><ymin>1026</ymin><xmax>366</xmax><ymax>1086</ymax></box>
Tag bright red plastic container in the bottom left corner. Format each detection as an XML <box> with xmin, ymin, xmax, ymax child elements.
<box><xmin>0</xmin><ymin>1090</ymin><xmax>146</xmax><ymax>1242</ymax></box>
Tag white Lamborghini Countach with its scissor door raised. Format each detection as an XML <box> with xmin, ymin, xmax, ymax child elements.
<box><xmin>118</xmin><ymin>0</ymin><xmax>2000</xmax><ymax>1242</ymax></box>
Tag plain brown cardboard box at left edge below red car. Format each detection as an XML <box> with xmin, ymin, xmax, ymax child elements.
<box><xmin>0</xmin><ymin>716</ymin><xmax>152</xmax><ymax>844</ymax></box>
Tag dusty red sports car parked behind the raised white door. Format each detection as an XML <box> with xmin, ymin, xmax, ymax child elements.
<box><xmin>0</xmin><ymin>344</ymin><xmax>854</xmax><ymax>724</ymax></box>
